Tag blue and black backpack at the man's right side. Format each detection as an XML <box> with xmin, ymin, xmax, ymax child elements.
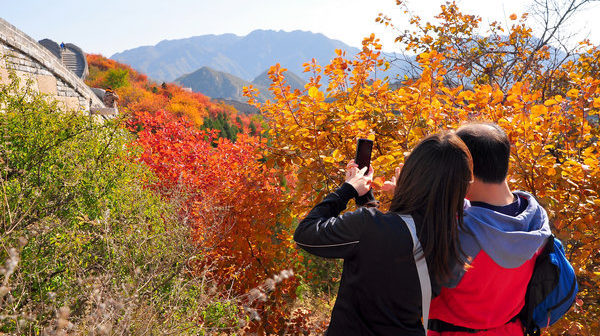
<box><xmin>519</xmin><ymin>235</ymin><xmax>578</xmax><ymax>336</ymax></box>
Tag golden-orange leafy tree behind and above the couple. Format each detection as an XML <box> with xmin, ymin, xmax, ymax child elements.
<box><xmin>246</xmin><ymin>2</ymin><xmax>600</xmax><ymax>335</ymax></box>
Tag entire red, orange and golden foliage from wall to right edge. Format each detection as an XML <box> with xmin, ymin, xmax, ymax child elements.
<box><xmin>82</xmin><ymin>2</ymin><xmax>600</xmax><ymax>335</ymax></box>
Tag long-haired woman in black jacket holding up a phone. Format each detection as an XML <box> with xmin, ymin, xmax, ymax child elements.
<box><xmin>294</xmin><ymin>133</ymin><xmax>473</xmax><ymax>336</ymax></box>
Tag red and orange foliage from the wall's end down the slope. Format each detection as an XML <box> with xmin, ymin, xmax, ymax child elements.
<box><xmin>87</xmin><ymin>55</ymin><xmax>298</xmax><ymax>333</ymax></box>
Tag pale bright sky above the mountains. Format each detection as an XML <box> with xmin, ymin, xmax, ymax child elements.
<box><xmin>0</xmin><ymin>0</ymin><xmax>600</xmax><ymax>56</ymax></box>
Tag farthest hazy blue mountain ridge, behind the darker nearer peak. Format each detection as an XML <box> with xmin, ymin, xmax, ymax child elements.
<box><xmin>111</xmin><ymin>30</ymin><xmax>359</xmax><ymax>81</ymax></box>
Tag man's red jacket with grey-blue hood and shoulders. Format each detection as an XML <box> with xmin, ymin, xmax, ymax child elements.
<box><xmin>430</xmin><ymin>191</ymin><xmax>551</xmax><ymax>335</ymax></box>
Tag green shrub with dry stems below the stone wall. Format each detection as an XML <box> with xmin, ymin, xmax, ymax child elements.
<box><xmin>0</xmin><ymin>70</ymin><xmax>223</xmax><ymax>334</ymax></box>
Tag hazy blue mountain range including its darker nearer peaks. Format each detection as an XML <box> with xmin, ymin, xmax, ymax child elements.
<box><xmin>111</xmin><ymin>30</ymin><xmax>414</xmax><ymax>103</ymax></box>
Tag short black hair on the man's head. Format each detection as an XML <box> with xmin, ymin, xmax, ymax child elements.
<box><xmin>456</xmin><ymin>123</ymin><xmax>510</xmax><ymax>183</ymax></box>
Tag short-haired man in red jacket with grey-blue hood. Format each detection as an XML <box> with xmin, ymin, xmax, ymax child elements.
<box><xmin>428</xmin><ymin>123</ymin><xmax>550</xmax><ymax>336</ymax></box>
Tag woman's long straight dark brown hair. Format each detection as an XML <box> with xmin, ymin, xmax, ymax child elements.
<box><xmin>390</xmin><ymin>132</ymin><xmax>473</xmax><ymax>282</ymax></box>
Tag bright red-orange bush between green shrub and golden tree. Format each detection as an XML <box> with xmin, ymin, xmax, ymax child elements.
<box><xmin>129</xmin><ymin>111</ymin><xmax>298</xmax><ymax>332</ymax></box>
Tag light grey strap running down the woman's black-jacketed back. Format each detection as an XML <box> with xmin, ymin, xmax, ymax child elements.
<box><xmin>399</xmin><ymin>215</ymin><xmax>431</xmax><ymax>335</ymax></box>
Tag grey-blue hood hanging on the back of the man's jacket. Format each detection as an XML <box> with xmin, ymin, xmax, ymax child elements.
<box><xmin>464</xmin><ymin>191</ymin><xmax>551</xmax><ymax>268</ymax></box>
